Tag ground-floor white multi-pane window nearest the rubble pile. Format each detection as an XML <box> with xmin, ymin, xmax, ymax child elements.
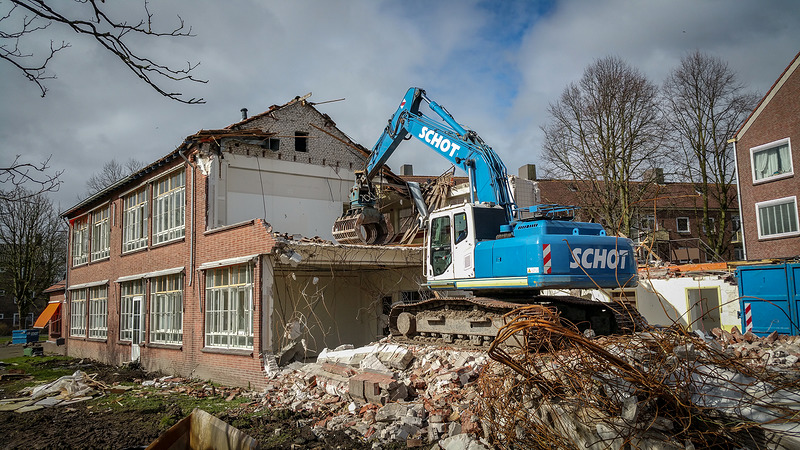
<box><xmin>206</xmin><ymin>264</ymin><xmax>253</xmax><ymax>348</ymax></box>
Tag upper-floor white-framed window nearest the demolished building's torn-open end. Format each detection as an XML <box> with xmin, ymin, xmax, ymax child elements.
<box><xmin>153</xmin><ymin>170</ymin><xmax>186</xmax><ymax>244</ymax></box>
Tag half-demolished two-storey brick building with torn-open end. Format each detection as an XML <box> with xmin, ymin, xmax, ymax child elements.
<box><xmin>62</xmin><ymin>97</ymin><xmax>422</xmax><ymax>387</ymax></box>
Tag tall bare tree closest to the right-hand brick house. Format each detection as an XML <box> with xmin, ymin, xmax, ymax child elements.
<box><xmin>663</xmin><ymin>51</ymin><xmax>758</xmax><ymax>255</ymax></box>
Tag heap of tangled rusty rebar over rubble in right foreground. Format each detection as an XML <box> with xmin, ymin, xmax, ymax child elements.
<box><xmin>478</xmin><ymin>305</ymin><xmax>800</xmax><ymax>449</ymax></box>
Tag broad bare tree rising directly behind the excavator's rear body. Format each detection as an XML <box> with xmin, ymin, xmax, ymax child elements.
<box><xmin>542</xmin><ymin>56</ymin><xmax>663</xmax><ymax>236</ymax></box>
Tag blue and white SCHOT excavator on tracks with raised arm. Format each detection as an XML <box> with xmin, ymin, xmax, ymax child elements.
<box><xmin>333</xmin><ymin>88</ymin><xmax>638</xmax><ymax>345</ymax></box>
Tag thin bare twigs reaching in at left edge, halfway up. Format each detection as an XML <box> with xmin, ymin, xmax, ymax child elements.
<box><xmin>0</xmin><ymin>155</ymin><xmax>64</xmax><ymax>200</ymax></box>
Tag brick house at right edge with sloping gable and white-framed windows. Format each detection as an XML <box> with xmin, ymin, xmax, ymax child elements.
<box><xmin>734</xmin><ymin>53</ymin><xmax>800</xmax><ymax>260</ymax></box>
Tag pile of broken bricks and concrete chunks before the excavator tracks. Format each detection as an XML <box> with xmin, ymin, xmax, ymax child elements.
<box><xmin>261</xmin><ymin>342</ymin><xmax>488</xmax><ymax>449</ymax></box>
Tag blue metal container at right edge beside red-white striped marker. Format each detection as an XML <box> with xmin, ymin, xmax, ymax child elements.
<box><xmin>736</xmin><ymin>263</ymin><xmax>800</xmax><ymax>336</ymax></box>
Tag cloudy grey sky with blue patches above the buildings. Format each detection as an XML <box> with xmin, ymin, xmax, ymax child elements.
<box><xmin>0</xmin><ymin>0</ymin><xmax>800</xmax><ymax>209</ymax></box>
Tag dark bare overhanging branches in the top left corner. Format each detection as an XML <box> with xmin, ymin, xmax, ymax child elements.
<box><xmin>0</xmin><ymin>0</ymin><xmax>205</xmax><ymax>104</ymax></box>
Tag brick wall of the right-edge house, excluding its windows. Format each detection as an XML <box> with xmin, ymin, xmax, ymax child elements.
<box><xmin>736</xmin><ymin>62</ymin><xmax>800</xmax><ymax>260</ymax></box>
